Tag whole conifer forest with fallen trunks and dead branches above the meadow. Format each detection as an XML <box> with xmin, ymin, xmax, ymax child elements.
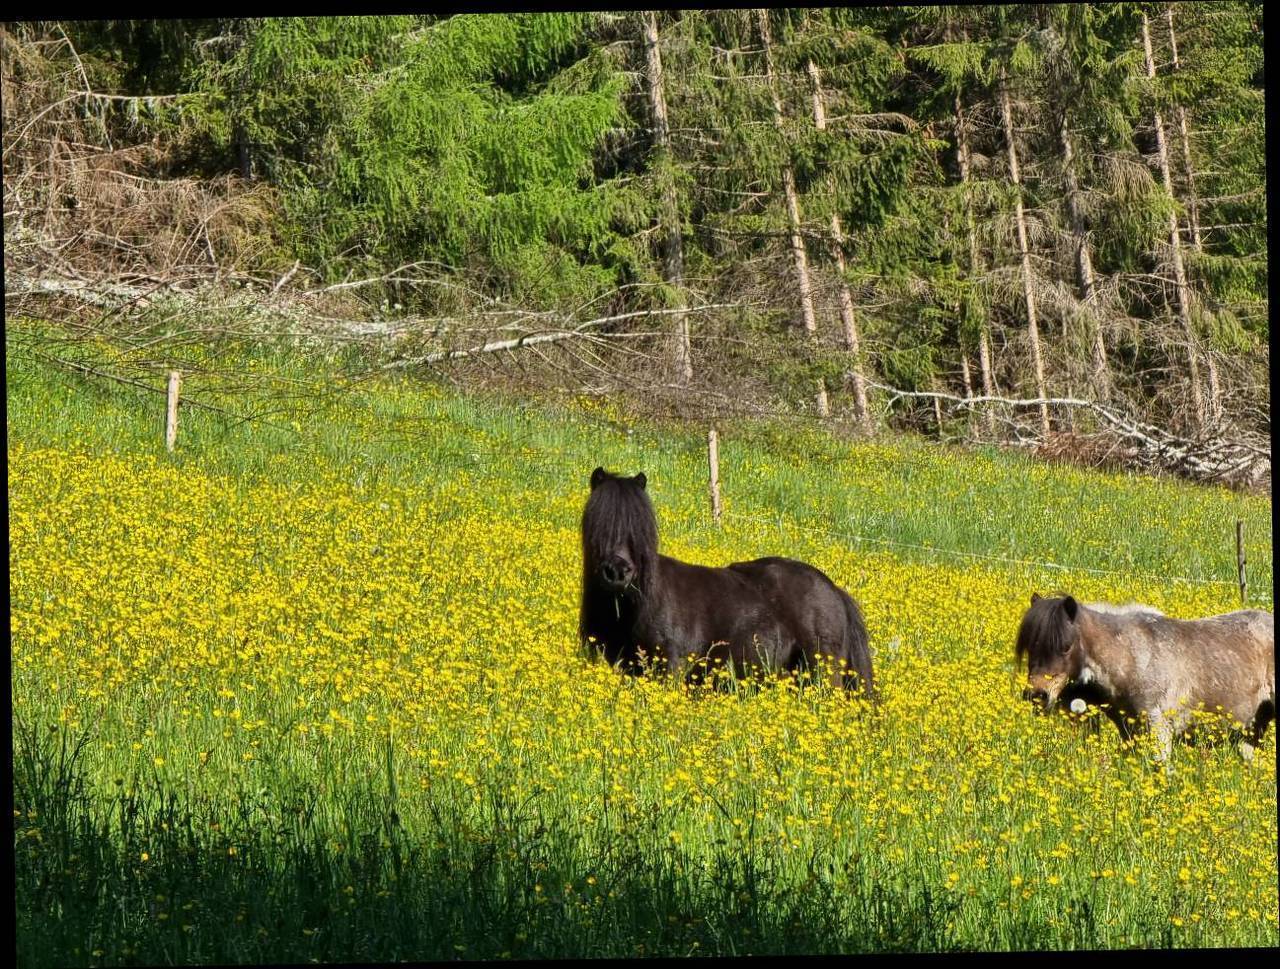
<box><xmin>3</xmin><ymin>9</ymin><xmax>1270</xmax><ymax>484</ymax></box>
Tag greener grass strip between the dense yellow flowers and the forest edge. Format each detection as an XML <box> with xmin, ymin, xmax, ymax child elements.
<box><xmin>6</xmin><ymin>321</ymin><xmax>1272</xmax><ymax>588</ymax></box>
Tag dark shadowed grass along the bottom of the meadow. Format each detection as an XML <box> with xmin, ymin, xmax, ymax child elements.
<box><xmin>14</xmin><ymin>725</ymin><xmax>954</xmax><ymax>969</ymax></box>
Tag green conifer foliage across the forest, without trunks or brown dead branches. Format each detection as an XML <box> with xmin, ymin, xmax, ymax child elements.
<box><xmin>27</xmin><ymin>3</ymin><xmax>1270</xmax><ymax>435</ymax></box>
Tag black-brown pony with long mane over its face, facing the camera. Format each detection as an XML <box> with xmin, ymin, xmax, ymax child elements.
<box><xmin>579</xmin><ymin>467</ymin><xmax>874</xmax><ymax>698</ymax></box>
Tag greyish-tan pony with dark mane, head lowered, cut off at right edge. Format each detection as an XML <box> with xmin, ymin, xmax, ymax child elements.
<box><xmin>1015</xmin><ymin>593</ymin><xmax>1276</xmax><ymax>758</ymax></box>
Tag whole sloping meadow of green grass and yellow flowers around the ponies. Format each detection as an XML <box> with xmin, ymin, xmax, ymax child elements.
<box><xmin>6</xmin><ymin>325</ymin><xmax>1280</xmax><ymax>966</ymax></box>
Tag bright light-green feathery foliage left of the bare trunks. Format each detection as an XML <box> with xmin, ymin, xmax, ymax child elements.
<box><xmin>184</xmin><ymin>14</ymin><xmax>623</xmax><ymax>301</ymax></box>
